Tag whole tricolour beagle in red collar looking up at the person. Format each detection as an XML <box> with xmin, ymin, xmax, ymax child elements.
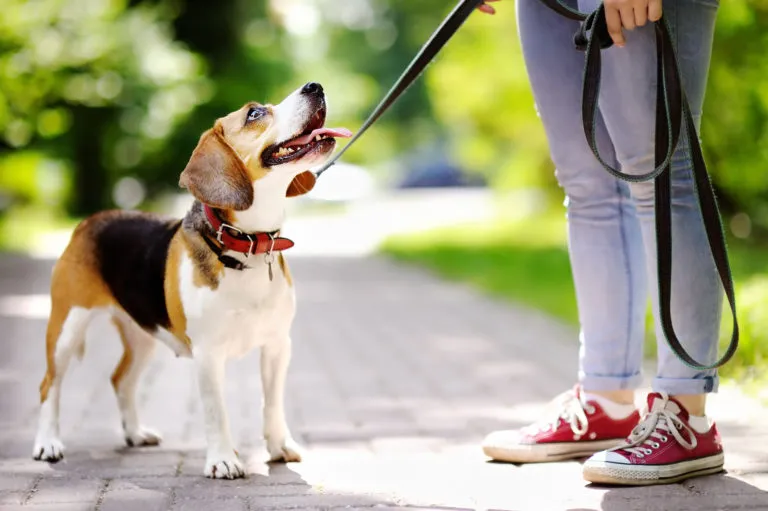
<box><xmin>33</xmin><ymin>83</ymin><xmax>351</xmax><ymax>479</ymax></box>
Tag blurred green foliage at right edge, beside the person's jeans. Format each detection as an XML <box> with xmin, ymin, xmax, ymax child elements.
<box><xmin>702</xmin><ymin>0</ymin><xmax>768</xmax><ymax>231</ymax></box>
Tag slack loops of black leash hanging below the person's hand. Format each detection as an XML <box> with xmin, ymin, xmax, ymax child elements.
<box><xmin>541</xmin><ymin>0</ymin><xmax>739</xmax><ymax>371</ymax></box>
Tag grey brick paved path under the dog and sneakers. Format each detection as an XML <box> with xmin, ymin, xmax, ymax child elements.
<box><xmin>0</xmin><ymin>256</ymin><xmax>768</xmax><ymax>511</ymax></box>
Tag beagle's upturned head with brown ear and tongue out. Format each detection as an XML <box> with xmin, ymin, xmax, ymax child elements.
<box><xmin>179</xmin><ymin>83</ymin><xmax>351</xmax><ymax>211</ymax></box>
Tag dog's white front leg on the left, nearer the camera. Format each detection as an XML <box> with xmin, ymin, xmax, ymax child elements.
<box><xmin>194</xmin><ymin>350</ymin><xmax>245</xmax><ymax>479</ymax></box>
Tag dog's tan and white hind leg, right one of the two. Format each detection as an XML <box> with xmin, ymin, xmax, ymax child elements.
<box><xmin>112</xmin><ymin>314</ymin><xmax>161</xmax><ymax>447</ymax></box>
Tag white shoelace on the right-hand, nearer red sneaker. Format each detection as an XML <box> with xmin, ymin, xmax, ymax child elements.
<box><xmin>612</xmin><ymin>392</ymin><xmax>697</xmax><ymax>458</ymax></box>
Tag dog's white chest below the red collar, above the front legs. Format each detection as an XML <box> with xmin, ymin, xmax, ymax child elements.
<box><xmin>180</xmin><ymin>254</ymin><xmax>295</xmax><ymax>357</ymax></box>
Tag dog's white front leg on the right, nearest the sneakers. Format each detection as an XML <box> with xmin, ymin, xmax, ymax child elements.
<box><xmin>261</xmin><ymin>338</ymin><xmax>301</xmax><ymax>462</ymax></box>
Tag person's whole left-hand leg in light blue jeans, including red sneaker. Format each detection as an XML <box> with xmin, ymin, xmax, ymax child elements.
<box><xmin>484</xmin><ymin>0</ymin><xmax>647</xmax><ymax>461</ymax></box>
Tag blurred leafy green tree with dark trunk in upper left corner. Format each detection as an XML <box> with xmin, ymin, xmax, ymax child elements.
<box><xmin>0</xmin><ymin>0</ymin><xmax>209</xmax><ymax>214</ymax></box>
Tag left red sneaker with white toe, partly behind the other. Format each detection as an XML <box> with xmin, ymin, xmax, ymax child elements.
<box><xmin>483</xmin><ymin>385</ymin><xmax>640</xmax><ymax>463</ymax></box>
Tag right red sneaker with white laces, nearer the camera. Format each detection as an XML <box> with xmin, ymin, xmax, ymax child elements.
<box><xmin>584</xmin><ymin>393</ymin><xmax>723</xmax><ymax>485</ymax></box>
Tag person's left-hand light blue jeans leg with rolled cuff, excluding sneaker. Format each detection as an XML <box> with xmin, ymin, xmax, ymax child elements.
<box><xmin>517</xmin><ymin>0</ymin><xmax>647</xmax><ymax>402</ymax></box>
